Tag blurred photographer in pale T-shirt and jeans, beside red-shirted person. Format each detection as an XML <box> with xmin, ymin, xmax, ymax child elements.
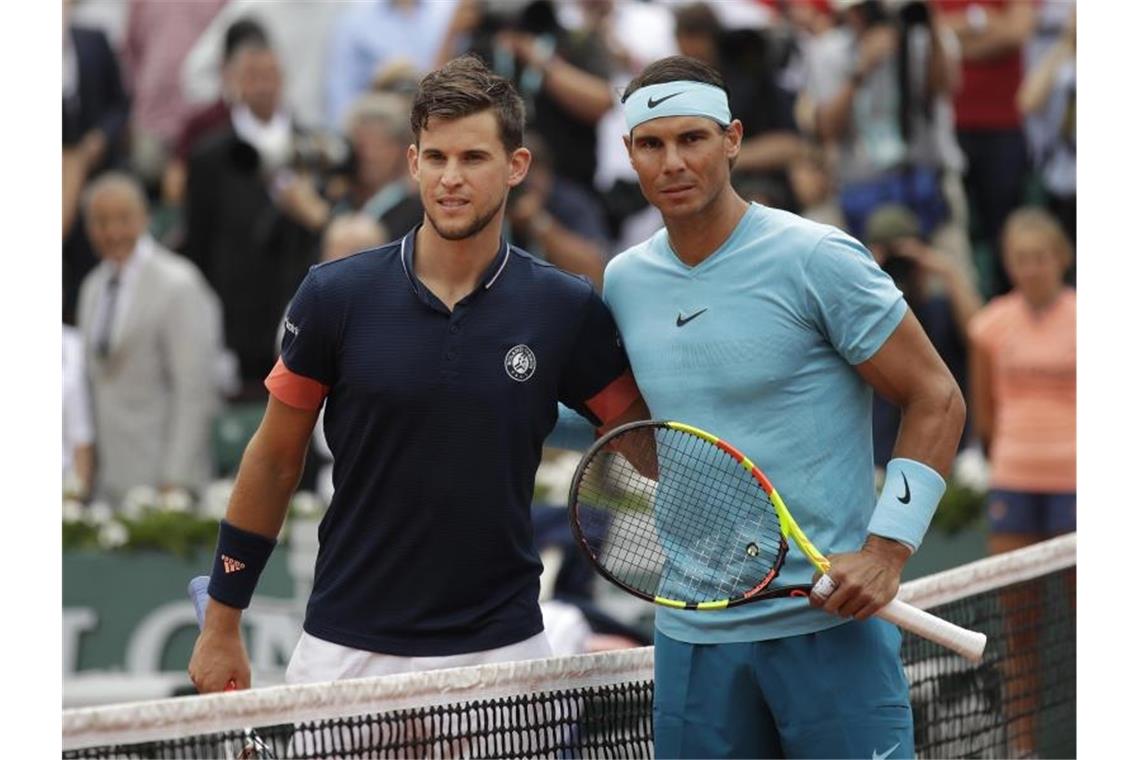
<box><xmin>807</xmin><ymin>0</ymin><xmax>974</xmax><ymax>284</ymax></box>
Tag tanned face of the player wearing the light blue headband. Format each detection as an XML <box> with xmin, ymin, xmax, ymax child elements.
<box><xmin>626</xmin><ymin>116</ymin><xmax>742</xmax><ymax>218</ymax></box>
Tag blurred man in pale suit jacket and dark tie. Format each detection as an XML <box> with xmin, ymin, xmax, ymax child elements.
<box><xmin>79</xmin><ymin>173</ymin><xmax>222</xmax><ymax>505</ymax></box>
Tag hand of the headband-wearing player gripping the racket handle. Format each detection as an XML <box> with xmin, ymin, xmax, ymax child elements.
<box><xmin>808</xmin><ymin>536</ymin><xmax>911</xmax><ymax>620</ymax></box>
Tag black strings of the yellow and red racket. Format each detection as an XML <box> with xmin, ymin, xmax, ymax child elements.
<box><xmin>577</xmin><ymin>427</ymin><xmax>781</xmax><ymax>603</ymax></box>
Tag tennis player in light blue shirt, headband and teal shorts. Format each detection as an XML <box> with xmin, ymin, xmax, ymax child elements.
<box><xmin>604</xmin><ymin>57</ymin><xmax>964</xmax><ymax>759</ymax></box>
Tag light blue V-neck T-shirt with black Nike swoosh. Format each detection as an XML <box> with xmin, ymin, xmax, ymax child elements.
<box><xmin>603</xmin><ymin>204</ymin><xmax>906</xmax><ymax>644</ymax></box>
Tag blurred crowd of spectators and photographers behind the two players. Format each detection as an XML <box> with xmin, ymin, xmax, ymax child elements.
<box><xmin>63</xmin><ymin>0</ymin><xmax>1076</xmax><ymax>558</ymax></box>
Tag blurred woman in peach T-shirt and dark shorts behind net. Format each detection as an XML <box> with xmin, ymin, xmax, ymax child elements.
<box><xmin>969</xmin><ymin>209</ymin><xmax>1076</xmax><ymax>758</ymax></box>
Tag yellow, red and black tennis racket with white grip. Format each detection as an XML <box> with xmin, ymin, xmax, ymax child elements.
<box><xmin>570</xmin><ymin>420</ymin><xmax>986</xmax><ymax>662</ymax></box>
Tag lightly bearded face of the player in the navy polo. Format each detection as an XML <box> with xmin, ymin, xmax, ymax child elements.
<box><xmin>408</xmin><ymin>111</ymin><xmax>530</xmax><ymax>240</ymax></box>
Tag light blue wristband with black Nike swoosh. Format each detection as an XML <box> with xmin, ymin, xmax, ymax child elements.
<box><xmin>868</xmin><ymin>457</ymin><xmax>946</xmax><ymax>551</ymax></box>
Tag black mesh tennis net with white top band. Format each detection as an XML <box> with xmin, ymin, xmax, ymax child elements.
<box><xmin>63</xmin><ymin>534</ymin><xmax>1076</xmax><ymax>758</ymax></box>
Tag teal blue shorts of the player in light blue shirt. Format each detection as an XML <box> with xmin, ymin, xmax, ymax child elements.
<box><xmin>653</xmin><ymin>613</ymin><xmax>914</xmax><ymax>760</ymax></box>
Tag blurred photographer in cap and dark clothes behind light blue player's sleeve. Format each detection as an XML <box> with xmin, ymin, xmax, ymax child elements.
<box><xmin>864</xmin><ymin>204</ymin><xmax>982</xmax><ymax>467</ymax></box>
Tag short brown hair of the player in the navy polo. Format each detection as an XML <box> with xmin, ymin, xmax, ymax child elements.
<box><xmin>412</xmin><ymin>56</ymin><xmax>527</xmax><ymax>153</ymax></box>
